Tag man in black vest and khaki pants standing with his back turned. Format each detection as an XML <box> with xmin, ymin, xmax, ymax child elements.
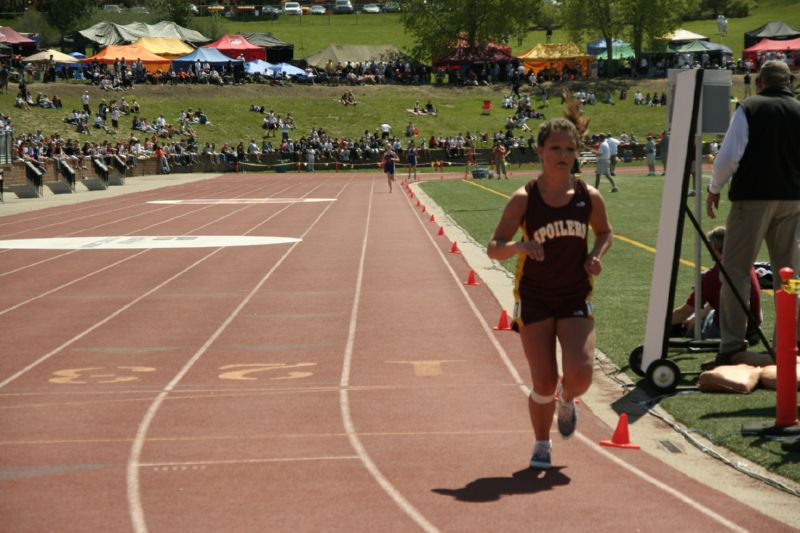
<box><xmin>706</xmin><ymin>61</ymin><xmax>800</xmax><ymax>364</ymax></box>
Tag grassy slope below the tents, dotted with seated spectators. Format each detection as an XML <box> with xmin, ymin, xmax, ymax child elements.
<box><xmin>0</xmin><ymin>80</ymin><xmax>680</xmax><ymax>145</ymax></box>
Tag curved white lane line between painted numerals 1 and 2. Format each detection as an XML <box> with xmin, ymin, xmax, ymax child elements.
<box><xmin>339</xmin><ymin>178</ymin><xmax>439</xmax><ymax>532</ymax></box>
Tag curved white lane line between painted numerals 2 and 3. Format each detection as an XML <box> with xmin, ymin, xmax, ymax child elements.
<box><xmin>126</xmin><ymin>180</ymin><xmax>347</xmax><ymax>533</ymax></box>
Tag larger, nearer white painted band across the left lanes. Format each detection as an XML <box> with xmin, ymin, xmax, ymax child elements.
<box><xmin>0</xmin><ymin>235</ymin><xmax>299</xmax><ymax>250</ymax></box>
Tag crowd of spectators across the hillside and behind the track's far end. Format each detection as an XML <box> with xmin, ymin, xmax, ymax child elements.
<box><xmin>0</xmin><ymin>43</ymin><xmax>792</xmax><ymax>177</ymax></box>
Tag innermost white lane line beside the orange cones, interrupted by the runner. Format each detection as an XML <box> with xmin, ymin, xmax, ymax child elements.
<box><xmin>406</xmin><ymin>184</ymin><xmax>747</xmax><ymax>532</ymax></box>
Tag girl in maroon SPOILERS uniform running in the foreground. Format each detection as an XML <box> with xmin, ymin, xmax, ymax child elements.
<box><xmin>487</xmin><ymin>118</ymin><xmax>612</xmax><ymax>469</ymax></box>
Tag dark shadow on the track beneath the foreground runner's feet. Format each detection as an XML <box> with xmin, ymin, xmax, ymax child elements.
<box><xmin>432</xmin><ymin>466</ymin><xmax>571</xmax><ymax>503</ymax></box>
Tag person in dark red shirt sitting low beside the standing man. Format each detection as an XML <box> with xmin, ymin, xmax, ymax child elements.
<box><xmin>670</xmin><ymin>226</ymin><xmax>762</xmax><ymax>343</ymax></box>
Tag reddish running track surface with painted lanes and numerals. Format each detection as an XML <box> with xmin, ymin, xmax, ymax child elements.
<box><xmin>0</xmin><ymin>174</ymin><xmax>790</xmax><ymax>532</ymax></box>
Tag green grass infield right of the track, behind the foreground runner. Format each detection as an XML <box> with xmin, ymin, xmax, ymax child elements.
<box><xmin>422</xmin><ymin>169</ymin><xmax>800</xmax><ymax>481</ymax></box>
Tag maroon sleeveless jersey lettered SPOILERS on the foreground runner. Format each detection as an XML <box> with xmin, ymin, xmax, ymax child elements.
<box><xmin>514</xmin><ymin>179</ymin><xmax>592</xmax><ymax>304</ymax></box>
